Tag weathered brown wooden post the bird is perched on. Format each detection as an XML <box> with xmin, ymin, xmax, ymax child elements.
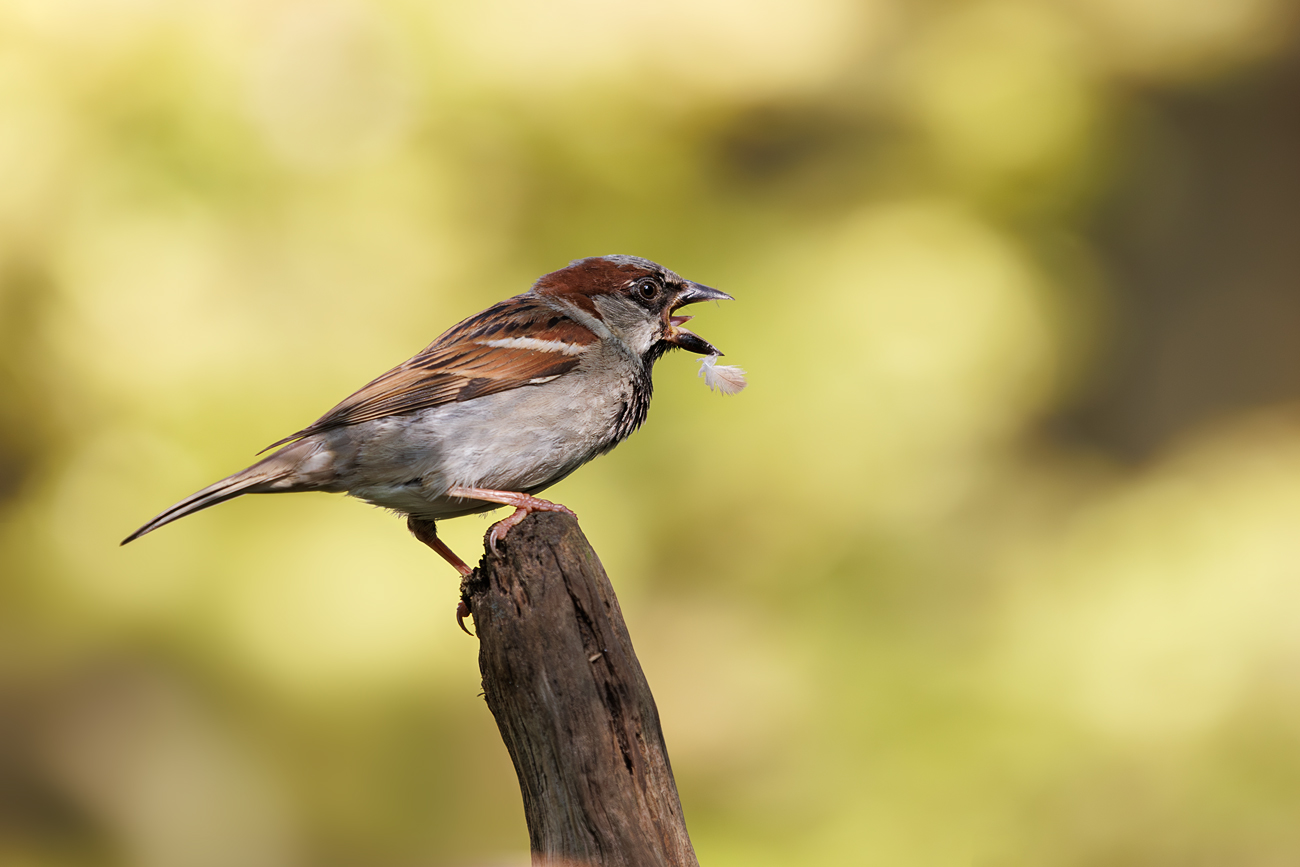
<box><xmin>462</xmin><ymin>512</ymin><xmax>699</xmax><ymax>867</ymax></box>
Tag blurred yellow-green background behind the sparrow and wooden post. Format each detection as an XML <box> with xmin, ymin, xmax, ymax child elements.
<box><xmin>0</xmin><ymin>0</ymin><xmax>1300</xmax><ymax>867</ymax></box>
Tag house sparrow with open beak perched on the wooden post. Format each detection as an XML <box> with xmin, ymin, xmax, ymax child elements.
<box><xmin>122</xmin><ymin>256</ymin><xmax>732</xmax><ymax>587</ymax></box>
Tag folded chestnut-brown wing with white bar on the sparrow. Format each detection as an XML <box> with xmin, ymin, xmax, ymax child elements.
<box><xmin>264</xmin><ymin>294</ymin><xmax>595</xmax><ymax>451</ymax></box>
